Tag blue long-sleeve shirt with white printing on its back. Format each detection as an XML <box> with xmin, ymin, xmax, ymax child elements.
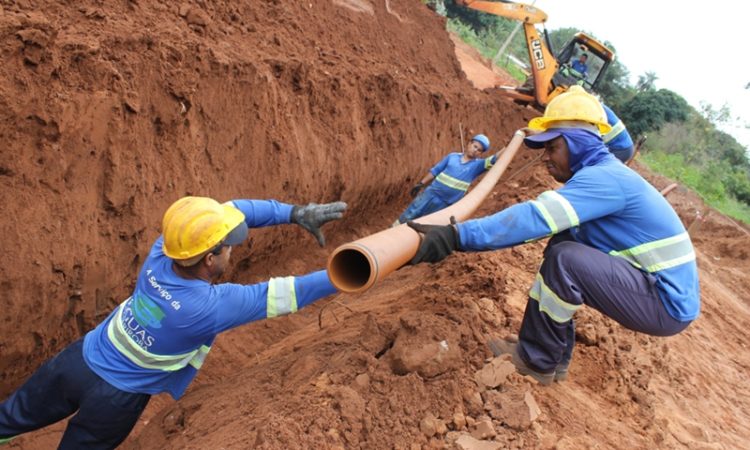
<box><xmin>83</xmin><ymin>200</ymin><xmax>336</xmax><ymax>399</ymax></box>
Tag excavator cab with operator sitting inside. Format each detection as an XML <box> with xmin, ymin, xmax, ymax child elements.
<box><xmin>552</xmin><ymin>33</ymin><xmax>615</xmax><ymax>91</ymax></box>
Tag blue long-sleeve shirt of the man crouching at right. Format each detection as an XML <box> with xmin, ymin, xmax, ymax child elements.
<box><xmin>458</xmin><ymin>154</ymin><xmax>700</xmax><ymax>321</ymax></box>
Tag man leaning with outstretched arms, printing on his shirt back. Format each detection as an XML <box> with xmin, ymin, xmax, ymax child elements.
<box><xmin>0</xmin><ymin>197</ymin><xmax>346</xmax><ymax>449</ymax></box>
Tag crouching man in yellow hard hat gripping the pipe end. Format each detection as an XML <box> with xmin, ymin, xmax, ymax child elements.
<box><xmin>409</xmin><ymin>86</ymin><xmax>700</xmax><ymax>385</ymax></box>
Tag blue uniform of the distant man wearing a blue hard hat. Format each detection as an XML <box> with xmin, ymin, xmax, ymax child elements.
<box><xmin>398</xmin><ymin>153</ymin><xmax>497</xmax><ymax>223</ymax></box>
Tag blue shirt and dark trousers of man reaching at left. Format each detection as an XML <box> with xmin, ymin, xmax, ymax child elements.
<box><xmin>0</xmin><ymin>200</ymin><xmax>336</xmax><ymax>448</ymax></box>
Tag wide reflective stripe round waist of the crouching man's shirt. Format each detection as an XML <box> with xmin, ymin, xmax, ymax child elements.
<box><xmin>609</xmin><ymin>232</ymin><xmax>695</xmax><ymax>272</ymax></box>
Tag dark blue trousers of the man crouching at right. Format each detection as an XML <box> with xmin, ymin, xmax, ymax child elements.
<box><xmin>518</xmin><ymin>233</ymin><xmax>690</xmax><ymax>373</ymax></box>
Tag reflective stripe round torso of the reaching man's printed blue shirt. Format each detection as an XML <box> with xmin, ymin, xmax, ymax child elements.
<box><xmin>107</xmin><ymin>299</ymin><xmax>211</xmax><ymax>372</ymax></box>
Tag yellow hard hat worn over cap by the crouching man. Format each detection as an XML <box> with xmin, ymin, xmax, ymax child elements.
<box><xmin>529</xmin><ymin>86</ymin><xmax>612</xmax><ymax>135</ymax></box>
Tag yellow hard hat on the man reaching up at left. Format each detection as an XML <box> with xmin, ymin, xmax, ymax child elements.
<box><xmin>161</xmin><ymin>197</ymin><xmax>247</xmax><ymax>265</ymax></box>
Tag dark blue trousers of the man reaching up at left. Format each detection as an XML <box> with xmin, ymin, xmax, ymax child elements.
<box><xmin>0</xmin><ymin>339</ymin><xmax>151</xmax><ymax>449</ymax></box>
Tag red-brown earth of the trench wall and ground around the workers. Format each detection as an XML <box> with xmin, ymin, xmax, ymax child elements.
<box><xmin>0</xmin><ymin>0</ymin><xmax>750</xmax><ymax>449</ymax></box>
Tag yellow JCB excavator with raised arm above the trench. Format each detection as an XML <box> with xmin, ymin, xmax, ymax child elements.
<box><xmin>456</xmin><ymin>0</ymin><xmax>615</xmax><ymax>111</ymax></box>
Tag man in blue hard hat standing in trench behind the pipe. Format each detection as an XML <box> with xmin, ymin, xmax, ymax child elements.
<box><xmin>393</xmin><ymin>134</ymin><xmax>499</xmax><ymax>226</ymax></box>
